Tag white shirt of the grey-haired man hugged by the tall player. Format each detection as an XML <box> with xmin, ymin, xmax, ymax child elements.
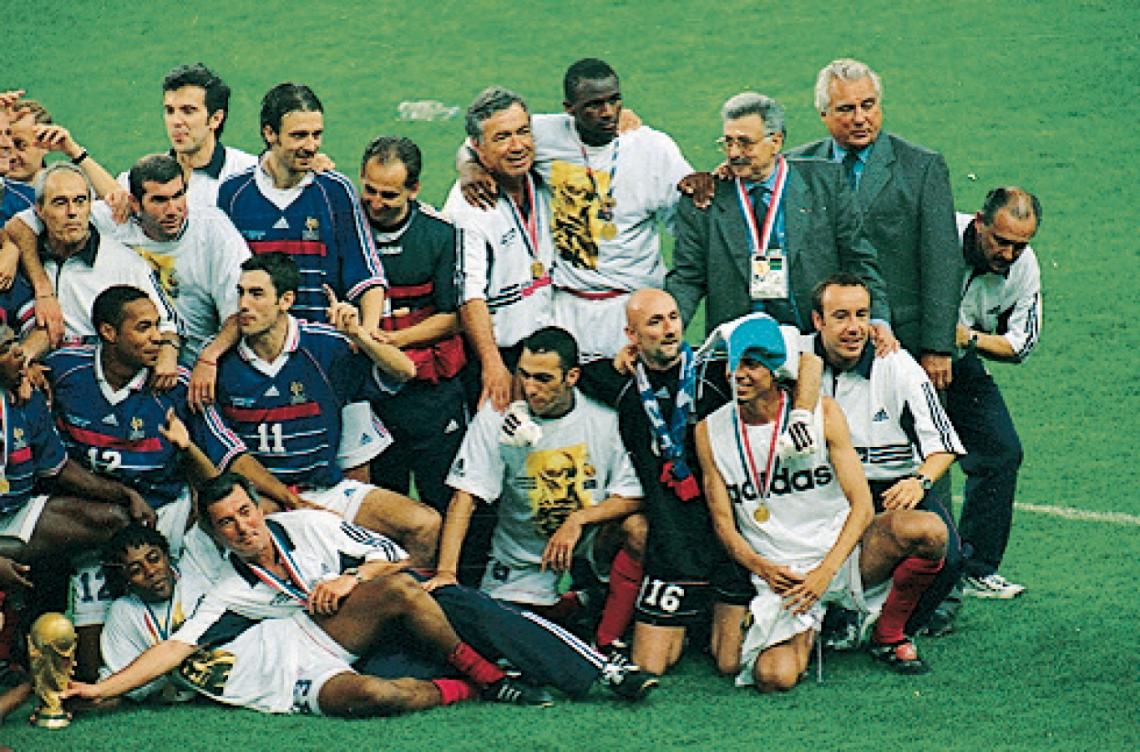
<box><xmin>443</xmin><ymin>179</ymin><xmax>554</xmax><ymax>348</ymax></box>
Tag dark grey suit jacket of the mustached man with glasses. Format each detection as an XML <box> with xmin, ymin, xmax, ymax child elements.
<box><xmin>665</xmin><ymin>158</ymin><xmax>890</xmax><ymax>333</ymax></box>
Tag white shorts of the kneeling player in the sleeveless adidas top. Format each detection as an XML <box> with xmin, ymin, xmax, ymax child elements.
<box><xmin>736</xmin><ymin>546</ymin><xmax>890</xmax><ymax>687</ymax></box>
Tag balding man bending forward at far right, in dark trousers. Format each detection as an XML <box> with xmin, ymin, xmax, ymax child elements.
<box><xmin>944</xmin><ymin>187</ymin><xmax>1041</xmax><ymax>606</ymax></box>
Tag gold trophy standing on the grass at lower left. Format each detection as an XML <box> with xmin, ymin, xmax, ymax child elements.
<box><xmin>27</xmin><ymin>613</ymin><xmax>75</xmax><ymax>728</ymax></box>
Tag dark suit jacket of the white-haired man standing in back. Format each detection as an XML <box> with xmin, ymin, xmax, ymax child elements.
<box><xmin>792</xmin><ymin>131</ymin><xmax>961</xmax><ymax>358</ymax></box>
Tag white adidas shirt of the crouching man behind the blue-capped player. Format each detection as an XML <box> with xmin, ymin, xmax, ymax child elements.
<box><xmin>801</xmin><ymin>334</ymin><xmax>966</xmax><ymax>481</ymax></box>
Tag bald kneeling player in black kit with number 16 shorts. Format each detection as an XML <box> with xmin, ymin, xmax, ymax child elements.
<box><xmin>579</xmin><ymin>288</ymin><xmax>819</xmax><ymax>673</ymax></box>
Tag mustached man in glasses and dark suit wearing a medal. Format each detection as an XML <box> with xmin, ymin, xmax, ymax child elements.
<box><xmin>666</xmin><ymin>91</ymin><xmax>894</xmax><ymax>349</ymax></box>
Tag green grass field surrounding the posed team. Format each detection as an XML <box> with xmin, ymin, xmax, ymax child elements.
<box><xmin>0</xmin><ymin>0</ymin><xmax>1140</xmax><ymax>752</ymax></box>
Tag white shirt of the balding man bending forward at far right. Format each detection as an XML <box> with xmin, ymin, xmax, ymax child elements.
<box><xmin>958</xmin><ymin>214</ymin><xmax>1041</xmax><ymax>362</ymax></box>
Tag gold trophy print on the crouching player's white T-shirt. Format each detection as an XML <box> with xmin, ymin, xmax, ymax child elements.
<box><xmin>524</xmin><ymin>443</ymin><xmax>596</xmax><ymax>538</ymax></box>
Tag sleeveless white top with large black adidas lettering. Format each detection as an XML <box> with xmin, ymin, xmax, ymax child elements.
<box><xmin>706</xmin><ymin>402</ymin><xmax>850</xmax><ymax>567</ymax></box>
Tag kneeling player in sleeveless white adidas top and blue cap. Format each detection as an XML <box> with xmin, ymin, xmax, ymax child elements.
<box><xmin>697</xmin><ymin>314</ymin><xmax>946</xmax><ymax>692</ymax></box>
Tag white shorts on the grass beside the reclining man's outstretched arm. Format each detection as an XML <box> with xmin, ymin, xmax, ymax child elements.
<box><xmin>176</xmin><ymin>612</ymin><xmax>357</xmax><ymax>716</ymax></box>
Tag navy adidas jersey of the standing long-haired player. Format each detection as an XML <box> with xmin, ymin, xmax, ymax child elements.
<box><xmin>218</xmin><ymin>164</ymin><xmax>386</xmax><ymax>321</ymax></box>
